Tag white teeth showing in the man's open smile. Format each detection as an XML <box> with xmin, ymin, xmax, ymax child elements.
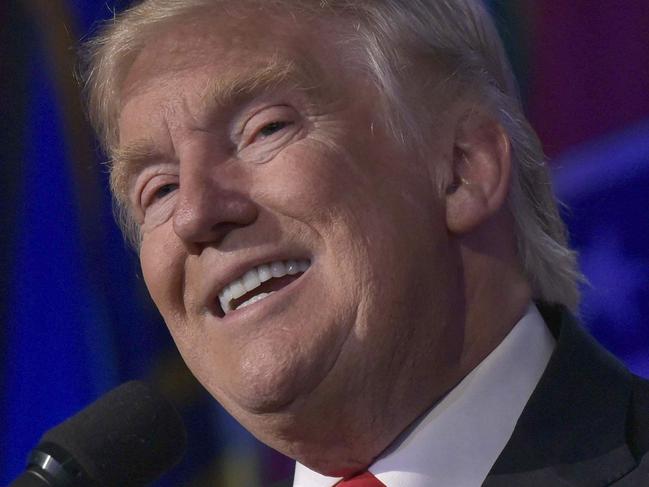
<box><xmin>219</xmin><ymin>260</ymin><xmax>311</xmax><ymax>314</ymax></box>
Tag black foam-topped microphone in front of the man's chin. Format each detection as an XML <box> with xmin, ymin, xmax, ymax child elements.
<box><xmin>9</xmin><ymin>381</ymin><xmax>187</xmax><ymax>487</ymax></box>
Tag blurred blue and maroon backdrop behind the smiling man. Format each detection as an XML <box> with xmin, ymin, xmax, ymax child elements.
<box><xmin>0</xmin><ymin>0</ymin><xmax>649</xmax><ymax>487</ymax></box>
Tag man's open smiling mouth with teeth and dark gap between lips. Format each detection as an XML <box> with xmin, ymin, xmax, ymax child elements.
<box><xmin>219</xmin><ymin>259</ymin><xmax>311</xmax><ymax>316</ymax></box>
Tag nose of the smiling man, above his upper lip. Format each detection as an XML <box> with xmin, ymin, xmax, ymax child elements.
<box><xmin>173</xmin><ymin>167</ymin><xmax>258</xmax><ymax>253</ymax></box>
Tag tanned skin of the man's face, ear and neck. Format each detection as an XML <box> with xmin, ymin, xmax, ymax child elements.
<box><xmin>116</xmin><ymin>4</ymin><xmax>529</xmax><ymax>476</ymax></box>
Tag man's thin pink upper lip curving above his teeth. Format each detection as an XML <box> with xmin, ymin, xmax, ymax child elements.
<box><xmin>200</xmin><ymin>251</ymin><xmax>313</xmax><ymax>311</ymax></box>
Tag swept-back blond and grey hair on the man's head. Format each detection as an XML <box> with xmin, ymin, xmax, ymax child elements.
<box><xmin>82</xmin><ymin>0</ymin><xmax>583</xmax><ymax>310</ymax></box>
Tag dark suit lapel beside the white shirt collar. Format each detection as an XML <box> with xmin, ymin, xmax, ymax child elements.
<box><xmin>483</xmin><ymin>306</ymin><xmax>636</xmax><ymax>487</ymax></box>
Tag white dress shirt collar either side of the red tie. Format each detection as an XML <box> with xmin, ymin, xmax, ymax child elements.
<box><xmin>293</xmin><ymin>304</ymin><xmax>555</xmax><ymax>487</ymax></box>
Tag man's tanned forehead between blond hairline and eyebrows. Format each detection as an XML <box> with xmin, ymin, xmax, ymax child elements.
<box><xmin>121</xmin><ymin>6</ymin><xmax>340</xmax><ymax>106</ymax></box>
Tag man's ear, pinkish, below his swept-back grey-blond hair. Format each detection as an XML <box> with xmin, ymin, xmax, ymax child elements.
<box><xmin>446</xmin><ymin>109</ymin><xmax>511</xmax><ymax>234</ymax></box>
